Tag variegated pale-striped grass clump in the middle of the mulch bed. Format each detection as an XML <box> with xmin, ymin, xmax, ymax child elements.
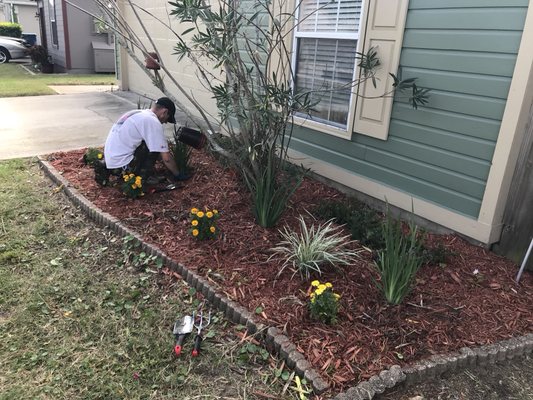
<box><xmin>271</xmin><ymin>216</ymin><xmax>359</xmax><ymax>279</ymax></box>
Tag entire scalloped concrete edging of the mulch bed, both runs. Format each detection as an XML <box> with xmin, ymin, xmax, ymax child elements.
<box><xmin>39</xmin><ymin>157</ymin><xmax>533</xmax><ymax>400</ymax></box>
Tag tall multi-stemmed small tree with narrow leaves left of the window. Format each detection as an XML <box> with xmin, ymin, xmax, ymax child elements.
<box><xmin>69</xmin><ymin>0</ymin><xmax>426</xmax><ymax>227</ymax></box>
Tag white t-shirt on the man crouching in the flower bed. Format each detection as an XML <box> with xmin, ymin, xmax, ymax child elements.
<box><xmin>104</xmin><ymin>110</ymin><xmax>168</xmax><ymax>169</ymax></box>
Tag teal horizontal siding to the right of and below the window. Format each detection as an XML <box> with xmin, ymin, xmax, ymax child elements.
<box><xmin>292</xmin><ymin>0</ymin><xmax>529</xmax><ymax>218</ymax></box>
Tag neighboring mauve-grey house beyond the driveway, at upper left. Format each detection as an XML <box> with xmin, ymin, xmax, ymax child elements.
<box><xmin>37</xmin><ymin>0</ymin><xmax>115</xmax><ymax>73</ymax></box>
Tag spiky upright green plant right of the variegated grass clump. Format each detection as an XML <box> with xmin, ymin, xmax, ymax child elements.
<box><xmin>375</xmin><ymin>211</ymin><xmax>422</xmax><ymax>304</ymax></box>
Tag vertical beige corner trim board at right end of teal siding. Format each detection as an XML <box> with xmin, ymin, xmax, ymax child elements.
<box><xmin>478</xmin><ymin>1</ymin><xmax>533</xmax><ymax>236</ymax></box>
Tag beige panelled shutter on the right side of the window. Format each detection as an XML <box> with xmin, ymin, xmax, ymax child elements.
<box><xmin>352</xmin><ymin>0</ymin><xmax>409</xmax><ymax>140</ymax></box>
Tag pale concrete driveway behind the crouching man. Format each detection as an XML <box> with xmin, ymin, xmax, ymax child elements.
<box><xmin>0</xmin><ymin>88</ymin><xmax>142</xmax><ymax>160</ymax></box>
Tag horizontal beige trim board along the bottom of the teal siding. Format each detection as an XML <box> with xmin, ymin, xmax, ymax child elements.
<box><xmin>289</xmin><ymin>150</ymin><xmax>494</xmax><ymax>244</ymax></box>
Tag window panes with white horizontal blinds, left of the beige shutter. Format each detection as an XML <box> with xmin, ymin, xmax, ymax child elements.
<box><xmin>293</xmin><ymin>0</ymin><xmax>362</xmax><ymax>128</ymax></box>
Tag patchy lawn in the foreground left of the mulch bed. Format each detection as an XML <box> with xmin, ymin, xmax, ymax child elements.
<box><xmin>0</xmin><ymin>159</ymin><xmax>304</xmax><ymax>400</ymax></box>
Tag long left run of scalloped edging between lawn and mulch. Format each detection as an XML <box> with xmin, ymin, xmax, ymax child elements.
<box><xmin>38</xmin><ymin>157</ymin><xmax>329</xmax><ymax>394</ymax></box>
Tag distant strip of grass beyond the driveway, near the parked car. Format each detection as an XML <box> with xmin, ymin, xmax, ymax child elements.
<box><xmin>0</xmin><ymin>63</ymin><xmax>116</xmax><ymax>97</ymax></box>
